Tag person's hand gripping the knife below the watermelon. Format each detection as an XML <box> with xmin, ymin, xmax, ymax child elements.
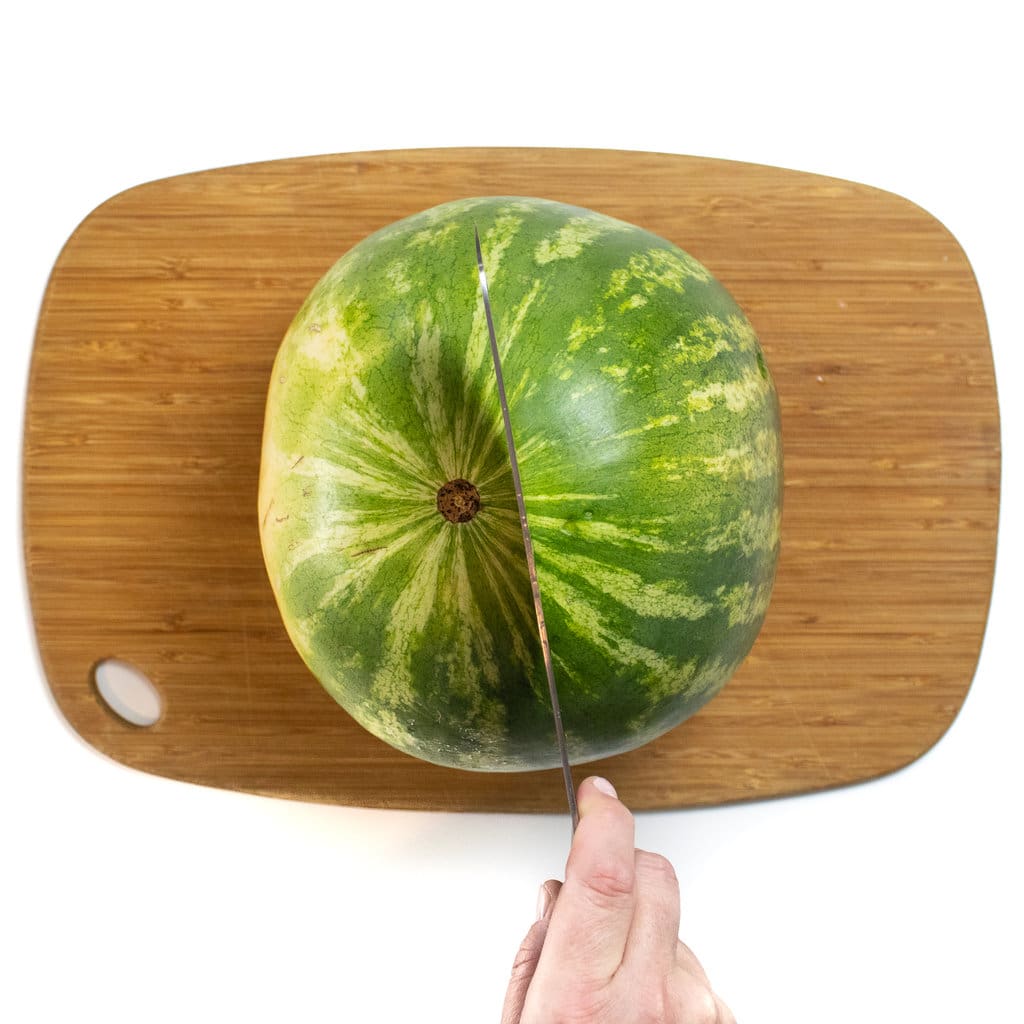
<box><xmin>502</xmin><ymin>778</ymin><xmax>735</xmax><ymax>1024</ymax></box>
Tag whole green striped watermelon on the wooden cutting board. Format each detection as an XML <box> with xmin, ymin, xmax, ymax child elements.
<box><xmin>259</xmin><ymin>197</ymin><xmax>781</xmax><ymax>771</ymax></box>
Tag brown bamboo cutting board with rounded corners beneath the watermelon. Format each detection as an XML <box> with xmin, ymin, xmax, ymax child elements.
<box><xmin>24</xmin><ymin>150</ymin><xmax>999</xmax><ymax>811</ymax></box>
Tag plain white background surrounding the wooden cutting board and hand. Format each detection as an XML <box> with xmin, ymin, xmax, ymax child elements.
<box><xmin>0</xmin><ymin>0</ymin><xmax>1024</xmax><ymax>1024</ymax></box>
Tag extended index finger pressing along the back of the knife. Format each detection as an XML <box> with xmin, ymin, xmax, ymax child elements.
<box><xmin>542</xmin><ymin>778</ymin><xmax>636</xmax><ymax>985</ymax></box>
